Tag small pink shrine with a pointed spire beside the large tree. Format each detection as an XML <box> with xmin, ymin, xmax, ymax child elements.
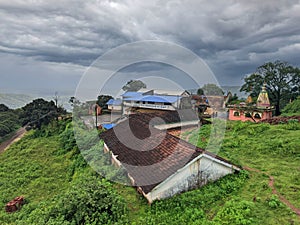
<box><xmin>228</xmin><ymin>83</ymin><xmax>274</xmax><ymax>122</ymax></box>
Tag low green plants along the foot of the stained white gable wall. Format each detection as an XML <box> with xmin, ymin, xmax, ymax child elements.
<box><xmin>137</xmin><ymin>171</ymin><xmax>248</xmax><ymax>225</ymax></box>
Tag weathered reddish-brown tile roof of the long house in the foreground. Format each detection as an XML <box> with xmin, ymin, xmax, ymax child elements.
<box><xmin>100</xmin><ymin>110</ymin><xmax>237</xmax><ymax>194</ymax></box>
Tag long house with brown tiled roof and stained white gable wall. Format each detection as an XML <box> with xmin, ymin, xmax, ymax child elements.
<box><xmin>100</xmin><ymin>112</ymin><xmax>239</xmax><ymax>203</ymax></box>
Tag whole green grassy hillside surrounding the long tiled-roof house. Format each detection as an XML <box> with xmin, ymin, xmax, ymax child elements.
<box><xmin>0</xmin><ymin>118</ymin><xmax>300</xmax><ymax>225</ymax></box>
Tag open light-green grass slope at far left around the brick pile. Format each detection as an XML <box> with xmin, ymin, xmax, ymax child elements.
<box><xmin>0</xmin><ymin>131</ymin><xmax>71</xmax><ymax>224</ymax></box>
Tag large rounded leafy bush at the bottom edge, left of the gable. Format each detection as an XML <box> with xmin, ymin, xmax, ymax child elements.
<box><xmin>49</xmin><ymin>176</ymin><xmax>126</xmax><ymax>224</ymax></box>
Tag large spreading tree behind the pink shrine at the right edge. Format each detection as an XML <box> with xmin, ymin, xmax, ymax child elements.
<box><xmin>240</xmin><ymin>61</ymin><xmax>300</xmax><ymax>115</ymax></box>
